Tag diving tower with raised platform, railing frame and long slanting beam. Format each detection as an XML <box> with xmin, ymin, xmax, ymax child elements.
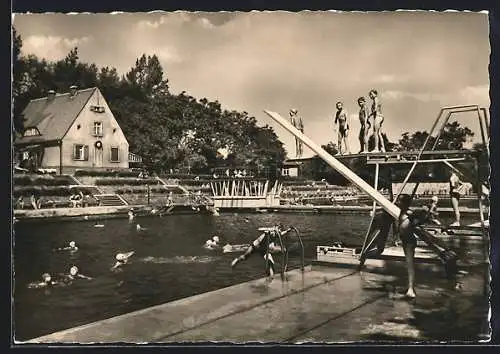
<box><xmin>264</xmin><ymin>105</ymin><xmax>489</xmax><ymax>273</ymax></box>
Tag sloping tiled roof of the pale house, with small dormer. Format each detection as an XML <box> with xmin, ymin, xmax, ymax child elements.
<box><xmin>16</xmin><ymin>87</ymin><xmax>97</xmax><ymax>143</ymax></box>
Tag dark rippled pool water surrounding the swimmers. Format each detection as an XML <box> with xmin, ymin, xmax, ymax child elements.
<box><xmin>14</xmin><ymin>213</ymin><xmax>478</xmax><ymax>340</ymax></box>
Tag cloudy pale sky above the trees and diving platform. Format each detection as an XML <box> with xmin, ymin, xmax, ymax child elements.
<box><xmin>13</xmin><ymin>11</ymin><xmax>490</xmax><ymax>157</ymax></box>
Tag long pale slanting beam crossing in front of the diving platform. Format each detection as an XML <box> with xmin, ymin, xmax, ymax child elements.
<box><xmin>264</xmin><ymin>110</ymin><xmax>400</xmax><ymax>218</ymax></box>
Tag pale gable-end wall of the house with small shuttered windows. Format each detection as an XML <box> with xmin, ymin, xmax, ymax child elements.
<box><xmin>63</xmin><ymin>90</ymin><xmax>129</xmax><ymax>171</ymax></box>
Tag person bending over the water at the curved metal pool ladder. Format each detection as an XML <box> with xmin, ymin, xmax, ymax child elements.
<box><xmin>231</xmin><ymin>224</ymin><xmax>291</xmax><ymax>277</ymax></box>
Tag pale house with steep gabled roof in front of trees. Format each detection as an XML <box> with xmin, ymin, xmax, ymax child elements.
<box><xmin>14</xmin><ymin>86</ymin><xmax>129</xmax><ymax>174</ymax></box>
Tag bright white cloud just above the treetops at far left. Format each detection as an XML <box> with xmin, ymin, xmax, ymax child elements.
<box><xmin>22</xmin><ymin>35</ymin><xmax>92</xmax><ymax>60</ymax></box>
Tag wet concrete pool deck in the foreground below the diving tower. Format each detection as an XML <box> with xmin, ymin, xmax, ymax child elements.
<box><xmin>25</xmin><ymin>267</ymin><xmax>488</xmax><ymax>344</ymax></box>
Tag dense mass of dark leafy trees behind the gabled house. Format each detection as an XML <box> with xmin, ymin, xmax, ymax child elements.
<box><xmin>12</xmin><ymin>29</ymin><xmax>286</xmax><ymax>172</ymax></box>
